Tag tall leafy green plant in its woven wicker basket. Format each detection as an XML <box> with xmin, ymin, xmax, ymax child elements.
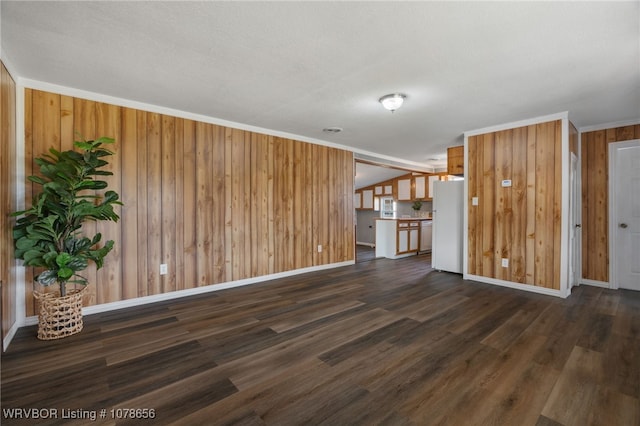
<box><xmin>13</xmin><ymin>137</ymin><xmax>122</xmax><ymax>340</ymax></box>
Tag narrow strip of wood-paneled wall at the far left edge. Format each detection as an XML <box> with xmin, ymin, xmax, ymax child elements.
<box><xmin>0</xmin><ymin>62</ymin><xmax>16</xmax><ymax>341</ymax></box>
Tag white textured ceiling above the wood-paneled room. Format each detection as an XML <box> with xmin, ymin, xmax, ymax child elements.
<box><xmin>0</xmin><ymin>0</ymin><xmax>640</xmax><ymax>181</ymax></box>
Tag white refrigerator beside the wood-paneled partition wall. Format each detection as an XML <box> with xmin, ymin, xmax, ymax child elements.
<box><xmin>431</xmin><ymin>180</ymin><xmax>464</xmax><ymax>274</ymax></box>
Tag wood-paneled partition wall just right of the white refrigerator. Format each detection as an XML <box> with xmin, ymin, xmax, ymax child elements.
<box><xmin>467</xmin><ymin>120</ymin><xmax>562</xmax><ymax>290</ymax></box>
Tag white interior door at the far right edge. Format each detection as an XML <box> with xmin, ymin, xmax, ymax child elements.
<box><xmin>609</xmin><ymin>140</ymin><xmax>640</xmax><ymax>291</ymax></box>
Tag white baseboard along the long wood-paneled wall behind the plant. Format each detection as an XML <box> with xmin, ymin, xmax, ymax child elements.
<box><xmin>18</xmin><ymin>260</ymin><xmax>355</xmax><ymax>332</ymax></box>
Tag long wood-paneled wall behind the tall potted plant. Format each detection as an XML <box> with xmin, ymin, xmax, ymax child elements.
<box><xmin>25</xmin><ymin>90</ymin><xmax>354</xmax><ymax>315</ymax></box>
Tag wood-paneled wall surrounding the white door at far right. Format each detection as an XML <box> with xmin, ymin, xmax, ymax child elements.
<box><xmin>581</xmin><ymin>124</ymin><xmax>640</xmax><ymax>282</ymax></box>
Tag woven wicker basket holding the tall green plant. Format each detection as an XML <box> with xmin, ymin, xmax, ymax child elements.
<box><xmin>33</xmin><ymin>287</ymin><xmax>86</xmax><ymax>340</ymax></box>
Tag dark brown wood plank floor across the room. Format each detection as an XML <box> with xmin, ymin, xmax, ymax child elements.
<box><xmin>2</xmin><ymin>256</ymin><xmax>640</xmax><ymax>426</ymax></box>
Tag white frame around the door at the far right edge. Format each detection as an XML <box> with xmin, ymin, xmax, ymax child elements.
<box><xmin>607</xmin><ymin>139</ymin><xmax>640</xmax><ymax>289</ymax></box>
